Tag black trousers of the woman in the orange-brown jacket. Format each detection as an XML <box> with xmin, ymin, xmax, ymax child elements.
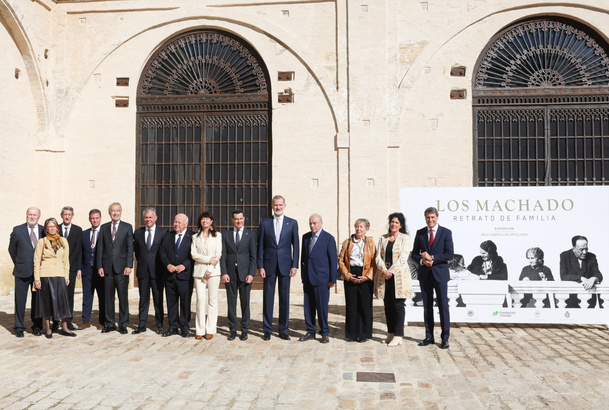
<box><xmin>344</xmin><ymin>266</ymin><xmax>374</xmax><ymax>340</ymax></box>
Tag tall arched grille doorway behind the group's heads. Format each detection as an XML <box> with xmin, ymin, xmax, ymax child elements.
<box><xmin>136</xmin><ymin>29</ymin><xmax>271</xmax><ymax>228</ymax></box>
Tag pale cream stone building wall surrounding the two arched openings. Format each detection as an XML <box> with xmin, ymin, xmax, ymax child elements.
<box><xmin>0</xmin><ymin>0</ymin><xmax>609</xmax><ymax>291</ymax></box>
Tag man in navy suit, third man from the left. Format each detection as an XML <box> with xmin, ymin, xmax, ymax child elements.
<box><xmin>76</xmin><ymin>209</ymin><xmax>106</xmax><ymax>330</ymax></box>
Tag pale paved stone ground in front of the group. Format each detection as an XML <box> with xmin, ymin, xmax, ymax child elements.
<box><xmin>0</xmin><ymin>290</ymin><xmax>609</xmax><ymax>410</ymax></box>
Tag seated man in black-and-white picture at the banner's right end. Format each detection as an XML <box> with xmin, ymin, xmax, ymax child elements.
<box><xmin>560</xmin><ymin>235</ymin><xmax>603</xmax><ymax>308</ymax></box>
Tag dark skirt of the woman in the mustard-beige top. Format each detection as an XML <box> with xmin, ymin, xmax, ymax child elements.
<box><xmin>34</xmin><ymin>276</ymin><xmax>71</xmax><ymax>320</ymax></box>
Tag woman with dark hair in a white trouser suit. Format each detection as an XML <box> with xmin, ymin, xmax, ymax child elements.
<box><xmin>190</xmin><ymin>212</ymin><xmax>222</xmax><ymax>340</ymax></box>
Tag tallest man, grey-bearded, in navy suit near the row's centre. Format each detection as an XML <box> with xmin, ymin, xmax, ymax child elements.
<box><xmin>258</xmin><ymin>195</ymin><xmax>299</xmax><ymax>340</ymax></box>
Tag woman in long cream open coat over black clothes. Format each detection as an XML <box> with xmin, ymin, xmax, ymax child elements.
<box><xmin>376</xmin><ymin>212</ymin><xmax>413</xmax><ymax>347</ymax></box>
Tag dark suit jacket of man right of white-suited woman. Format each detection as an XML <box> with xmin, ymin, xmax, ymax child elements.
<box><xmin>220</xmin><ymin>228</ymin><xmax>256</xmax><ymax>282</ymax></box>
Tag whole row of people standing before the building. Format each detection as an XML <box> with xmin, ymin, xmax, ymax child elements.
<box><xmin>9</xmin><ymin>199</ymin><xmax>453</xmax><ymax>348</ymax></box>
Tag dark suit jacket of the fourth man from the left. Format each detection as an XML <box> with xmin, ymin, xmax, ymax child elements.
<box><xmin>95</xmin><ymin>221</ymin><xmax>133</xmax><ymax>275</ymax></box>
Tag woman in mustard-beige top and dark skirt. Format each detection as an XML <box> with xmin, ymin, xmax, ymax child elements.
<box><xmin>33</xmin><ymin>218</ymin><xmax>76</xmax><ymax>339</ymax></box>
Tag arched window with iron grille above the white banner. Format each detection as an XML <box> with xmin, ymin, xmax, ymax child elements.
<box><xmin>473</xmin><ymin>18</ymin><xmax>609</xmax><ymax>186</ymax></box>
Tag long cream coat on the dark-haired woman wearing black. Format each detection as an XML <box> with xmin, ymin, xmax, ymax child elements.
<box><xmin>374</xmin><ymin>233</ymin><xmax>413</xmax><ymax>299</ymax></box>
